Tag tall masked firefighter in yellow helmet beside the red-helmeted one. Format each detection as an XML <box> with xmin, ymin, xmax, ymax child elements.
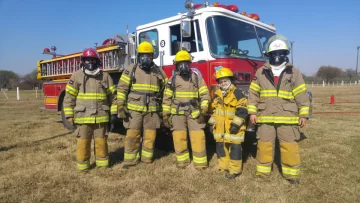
<box><xmin>117</xmin><ymin>41</ymin><xmax>167</xmax><ymax>169</ymax></box>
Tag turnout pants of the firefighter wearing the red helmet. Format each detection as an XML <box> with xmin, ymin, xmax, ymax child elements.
<box><xmin>75</xmin><ymin>123</ymin><xmax>109</xmax><ymax>170</ymax></box>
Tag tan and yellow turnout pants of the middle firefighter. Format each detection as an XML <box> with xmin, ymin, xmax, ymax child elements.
<box><xmin>172</xmin><ymin>115</ymin><xmax>208</xmax><ymax>168</ymax></box>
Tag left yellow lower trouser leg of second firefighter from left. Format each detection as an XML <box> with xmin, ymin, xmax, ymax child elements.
<box><xmin>122</xmin><ymin>129</ymin><xmax>140</xmax><ymax>169</ymax></box>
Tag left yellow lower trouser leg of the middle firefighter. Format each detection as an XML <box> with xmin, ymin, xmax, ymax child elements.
<box><xmin>173</xmin><ymin>131</ymin><xmax>190</xmax><ymax>169</ymax></box>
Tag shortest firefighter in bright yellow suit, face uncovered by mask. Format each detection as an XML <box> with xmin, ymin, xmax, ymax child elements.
<box><xmin>208</xmin><ymin>67</ymin><xmax>248</xmax><ymax>179</ymax></box>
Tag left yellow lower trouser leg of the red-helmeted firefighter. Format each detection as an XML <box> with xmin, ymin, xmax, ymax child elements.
<box><xmin>76</xmin><ymin>138</ymin><xmax>91</xmax><ymax>171</ymax></box>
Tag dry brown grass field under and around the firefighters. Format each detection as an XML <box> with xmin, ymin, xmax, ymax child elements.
<box><xmin>0</xmin><ymin>86</ymin><xmax>360</xmax><ymax>203</ymax></box>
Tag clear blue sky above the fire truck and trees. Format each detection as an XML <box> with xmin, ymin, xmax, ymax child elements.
<box><xmin>0</xmin><ymin>0</ymin><xmax>360</xmax><ymax>75</ymax></box>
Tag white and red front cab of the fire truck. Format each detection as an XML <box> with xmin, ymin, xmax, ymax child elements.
<box><xmin>136</xmin><ymin>1</ymin><xmax>275</xmax><ymax>93</ymax></box>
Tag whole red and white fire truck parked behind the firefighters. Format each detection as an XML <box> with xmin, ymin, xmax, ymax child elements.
<box><xmin>37</xmin><ymin>0</ymin><xmax>276</xmax><ymax>129</ymax></box>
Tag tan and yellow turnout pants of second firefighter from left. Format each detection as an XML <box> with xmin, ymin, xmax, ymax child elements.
<box><xmin>124</xmin><ymin>111</ymin><xmax>160</xmax><ymax>165</ymax></box>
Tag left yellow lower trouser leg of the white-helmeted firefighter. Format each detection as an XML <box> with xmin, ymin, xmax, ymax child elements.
<box><xmin>256</xmin><ymin>140</ymin><xmax>273</xmax><ymax>176</ymax></box>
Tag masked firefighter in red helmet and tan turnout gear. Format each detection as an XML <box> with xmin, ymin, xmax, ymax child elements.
<box><xmin>63</xmin><ymin>48</ymin><xmax>117</xmax><ymax>171</ymax></box>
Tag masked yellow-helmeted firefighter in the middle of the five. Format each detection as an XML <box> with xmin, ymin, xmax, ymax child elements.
<box><xmin>162</xmin><ymin>50</ymin><xmax>210</xmax><ymax>170</ymax></box>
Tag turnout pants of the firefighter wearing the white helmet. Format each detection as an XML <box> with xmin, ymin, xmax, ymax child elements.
<box><xmin>256</xmin><ymin>124</ymin><xmax>300</xmax><ymax>179</ymax></box>
